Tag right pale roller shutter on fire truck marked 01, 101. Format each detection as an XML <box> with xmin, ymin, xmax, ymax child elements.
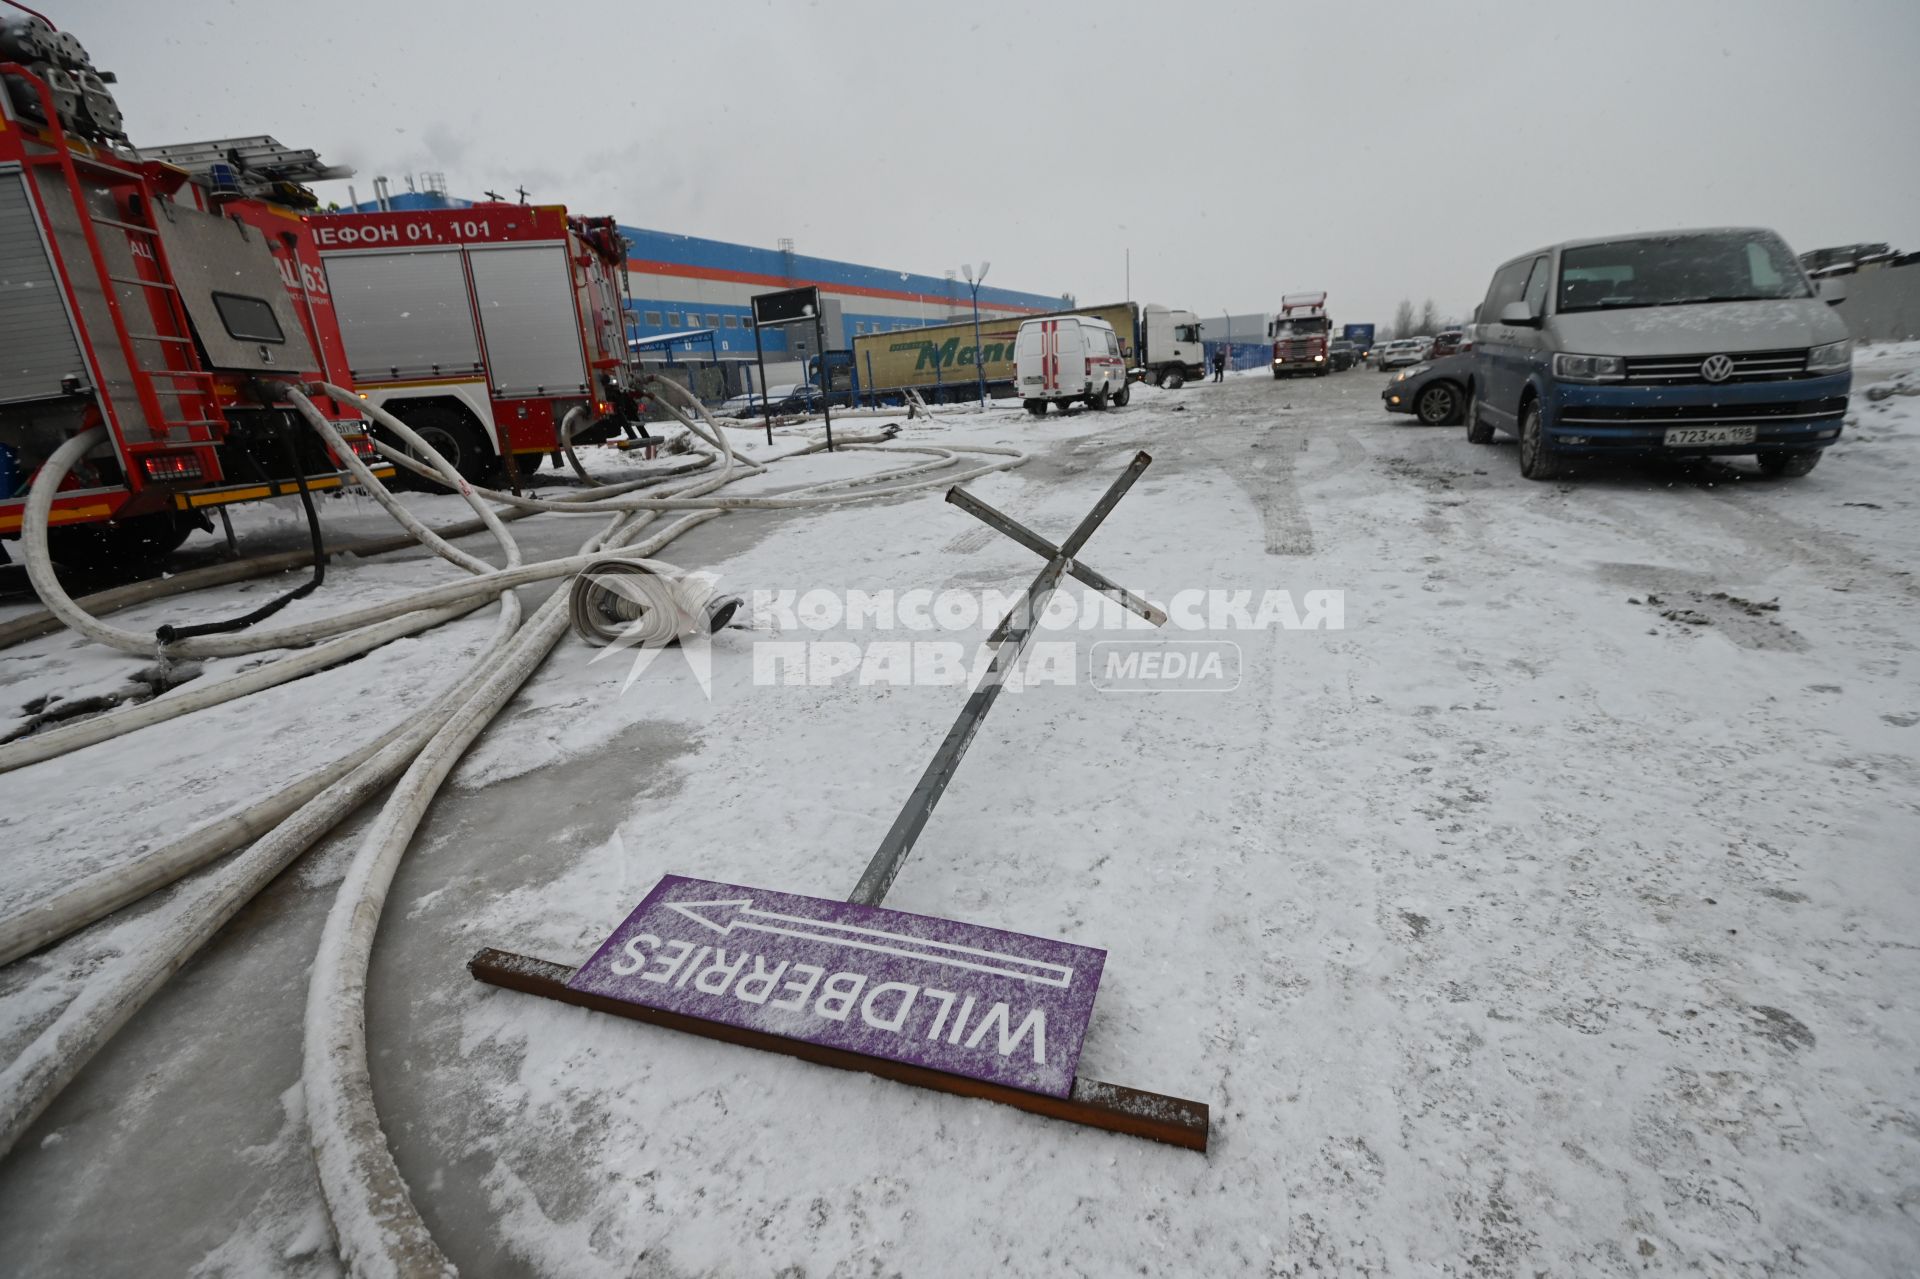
<box><xmin>468</xmin><ymin>244</ymin><xmax>591</xmax><ymax>399</ymax></box>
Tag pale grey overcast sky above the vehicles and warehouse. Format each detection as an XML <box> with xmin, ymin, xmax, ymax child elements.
<box><xmin>71</xmin><ymin>0</ymin><xmax>1920</xmax><ymax>323</ymax></box>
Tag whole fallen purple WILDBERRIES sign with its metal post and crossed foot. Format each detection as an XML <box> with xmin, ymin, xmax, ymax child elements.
<box><xmin>468</xmin><ymin>453</ymin><xmax>1210</xmax><ymax>1152</ymax></box>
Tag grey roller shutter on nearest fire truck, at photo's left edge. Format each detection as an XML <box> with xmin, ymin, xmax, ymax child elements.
<box><xmin>0</xmin><ymin>173</ymin><xmax>92</xmax><ymax>403</ymax></box>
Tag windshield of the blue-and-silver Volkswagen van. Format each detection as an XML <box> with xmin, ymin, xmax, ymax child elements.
<box><xmin>1557</xmin><ymin>232</ymin><xmax>1812</xmax><ymax>313</ymax></box>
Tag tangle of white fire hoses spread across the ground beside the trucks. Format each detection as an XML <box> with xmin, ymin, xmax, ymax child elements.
<box><xmin>0</xmin><ymin>382</ymin><xmax>1025</xmax><ymax>1275</ymax></box>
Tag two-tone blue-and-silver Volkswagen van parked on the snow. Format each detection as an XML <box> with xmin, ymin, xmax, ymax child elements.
<box><xmin>1467</xmin><ymin>229</ymin><xmax>1853</xmax><ymax>480</ymax></box>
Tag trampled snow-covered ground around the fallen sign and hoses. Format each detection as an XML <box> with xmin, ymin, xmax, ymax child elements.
<box><xmin>0</xmin><ymin>346</ymin><xmax>1920</xmax><ymax>1275</ymax></box>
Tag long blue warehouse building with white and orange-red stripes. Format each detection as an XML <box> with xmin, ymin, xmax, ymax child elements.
<box><xmin>353</xmin><ymin>190</ymin><xmax>1064</xmax><ymax>365</ymax></box>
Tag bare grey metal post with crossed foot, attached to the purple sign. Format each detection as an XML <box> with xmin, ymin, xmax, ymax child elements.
<box><xmin>847</xmin><ymin>453</ymin><xmax>1167</xmax><ymax>906</ymax></box>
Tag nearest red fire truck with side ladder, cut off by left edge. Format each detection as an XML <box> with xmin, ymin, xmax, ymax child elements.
<box><xmin>0</xmin><ymin>17</ymin><xmax>385</xmax><ymax>565</ymax></box>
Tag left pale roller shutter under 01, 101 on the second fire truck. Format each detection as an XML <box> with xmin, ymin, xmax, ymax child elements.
<box><xmin>323</xmin><ymin>248</ymin><xmax>480</xmax><ymax>382</ymax></box>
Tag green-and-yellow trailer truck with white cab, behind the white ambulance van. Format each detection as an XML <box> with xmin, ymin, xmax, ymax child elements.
<box><xmin>852</xmin><ymin>302</ymin><xmax>1206</xmax><ymax>399</ymax></box>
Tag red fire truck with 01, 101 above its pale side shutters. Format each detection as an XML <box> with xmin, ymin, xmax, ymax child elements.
<box><xmin>313</xmin><ymin>204</ymin><xmax>639</xmax><ymax>484</ymax></box>
